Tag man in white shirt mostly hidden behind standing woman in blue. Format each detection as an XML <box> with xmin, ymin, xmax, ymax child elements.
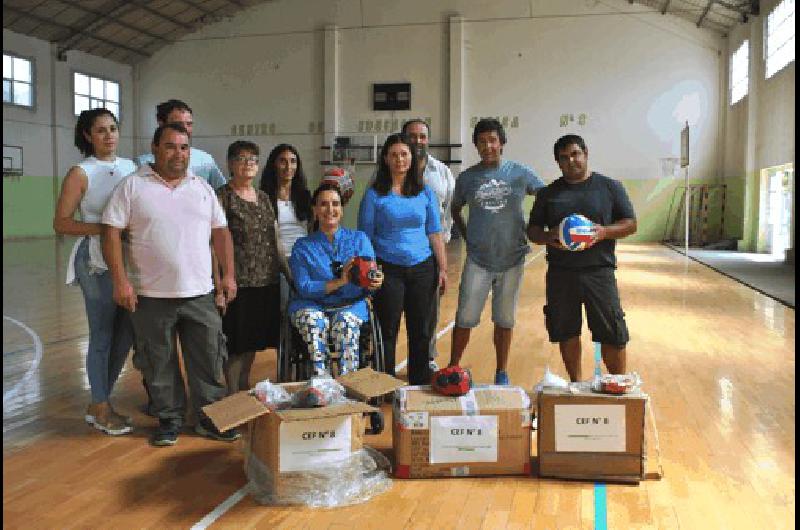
<box><xmin>400</xmin><ymin>119</ymin><xmax>456</xmax><ymax>372</ymax></box>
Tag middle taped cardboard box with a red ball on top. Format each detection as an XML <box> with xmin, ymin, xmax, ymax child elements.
<box><xmin>393</xmin><ymin>385</ymin><xmax>531</xmax><ymax>478</ymax></box>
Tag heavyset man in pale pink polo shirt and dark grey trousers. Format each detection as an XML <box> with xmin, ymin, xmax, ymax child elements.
<box><xmin>103</xmin><ymin>123</ymin><xmax>239</xmax><ymax>446</ymax></box>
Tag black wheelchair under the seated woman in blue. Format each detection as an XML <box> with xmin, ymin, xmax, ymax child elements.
<box><xmin>277</xmin><ymin>297</ymin><xmax>386</xmax><ymax>434</ymax></box>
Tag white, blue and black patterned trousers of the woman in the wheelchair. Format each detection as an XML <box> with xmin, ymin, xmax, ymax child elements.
<box><xmin>292</xmin><ymin>308</ymin><xmax>363</xmax><ymax>375</ymax></box>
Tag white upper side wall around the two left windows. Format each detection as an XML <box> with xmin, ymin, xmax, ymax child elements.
<box><xmin>3</xmin><ymin>29</ymin><xmax>133</xmax><ymax>177</ymax></box>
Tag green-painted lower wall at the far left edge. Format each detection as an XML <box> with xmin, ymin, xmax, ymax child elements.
<box><xmin>3</xmin><ymin>175</ymin><xmax>55</xmax><ymax>239</ymax></box>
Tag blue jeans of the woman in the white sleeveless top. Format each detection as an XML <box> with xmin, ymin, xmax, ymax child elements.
<box><xmin>75</xmin><ymin>238</ymin><xmax>133</xmax><ymax>403</ymax></box>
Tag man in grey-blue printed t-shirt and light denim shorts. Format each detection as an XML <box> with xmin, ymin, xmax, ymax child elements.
<box><xmin>450</xmin><ymin>118</ymin><xmax>544</xmax><ymax>385</ymax></box>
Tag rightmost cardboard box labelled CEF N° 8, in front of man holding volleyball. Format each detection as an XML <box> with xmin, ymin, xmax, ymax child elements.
<box><xmin>537</xmin><ymin>384</ymin><xmax>648</xmax><ymax>482</ymax></box>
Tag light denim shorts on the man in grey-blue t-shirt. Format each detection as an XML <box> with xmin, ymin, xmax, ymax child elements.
<box><xmin>456</xmin><ymin>255</ymin><xmax>525</xmax><ymax>328</ymax></box>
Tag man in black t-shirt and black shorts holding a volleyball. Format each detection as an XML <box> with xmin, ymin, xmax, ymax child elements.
<box><xmin>528</xmin><ymin>134</ymin><xmax>636</xmax><ymax>381</ymax></box>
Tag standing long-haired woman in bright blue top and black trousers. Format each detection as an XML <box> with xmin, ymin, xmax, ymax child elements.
<box><xmin>358</xmin><ymin>134</ymin><xmax>447</xmax><ymax>385</ymax></box>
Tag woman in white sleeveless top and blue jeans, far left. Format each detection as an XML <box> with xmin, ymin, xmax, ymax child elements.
<box><xmin>53</xmin><ymin>108</ymin><xmax>136</xmax><ymax>435</ymax></box>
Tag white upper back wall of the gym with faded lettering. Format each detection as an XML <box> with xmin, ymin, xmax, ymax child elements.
<box><xmin>137</xmin><ymin>0</ymin><xmax>724</xmax><ymax>189</ymax></box>
